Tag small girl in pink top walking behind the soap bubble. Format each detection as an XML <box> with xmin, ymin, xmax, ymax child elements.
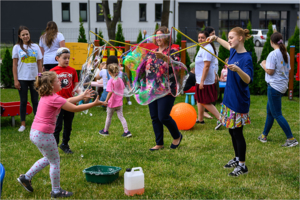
<box><xmin>99</xmin><ymin>63</ymin><xmax>132</xmax><ymax>137</ymax></box>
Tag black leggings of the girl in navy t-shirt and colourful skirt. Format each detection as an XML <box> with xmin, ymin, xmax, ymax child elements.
<box><xmin>229</xmin><ymin>126</ymin><xmax>246</xmax><ymax>162</ymax></box>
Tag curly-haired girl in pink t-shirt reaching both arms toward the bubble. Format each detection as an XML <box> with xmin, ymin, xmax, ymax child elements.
<box><xmin>17</xmin><ymin>71</ymin><xmax>105</xmax><ymax>198</ymax></box>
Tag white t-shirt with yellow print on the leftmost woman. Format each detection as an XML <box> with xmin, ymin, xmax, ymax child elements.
<box><xmin>12</xmin><ymin>44</ymin><xmax>43</xmax><ymax>81</ymax></box>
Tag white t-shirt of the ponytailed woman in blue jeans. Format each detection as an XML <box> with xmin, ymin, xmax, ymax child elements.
<box><xmin>265</xmin><ymin>49</ymin><xmax>291</xmax><ymax>93</ymax></box>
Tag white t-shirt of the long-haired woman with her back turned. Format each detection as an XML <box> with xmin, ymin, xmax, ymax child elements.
<box><xmin>39</xmin><ymin>33</ymin><xmax>65</xmax><ymax>65</ymax></box>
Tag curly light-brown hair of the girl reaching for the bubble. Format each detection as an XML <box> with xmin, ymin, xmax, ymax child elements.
<box><xmin>34</xmin><ymin>71</ymin><xmax>56</xmax><ymax>97</ymax></box>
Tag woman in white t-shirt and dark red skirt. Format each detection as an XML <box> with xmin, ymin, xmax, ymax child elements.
<box><xmin>195</xmin><ymin>31</ymin><xmax>220</xmax><ymax>129</ymax></box>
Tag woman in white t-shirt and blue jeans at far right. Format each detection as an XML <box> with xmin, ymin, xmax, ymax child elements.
<box><xmin>258</xmin><ymin>32</ymin><xmax>298</xmax><ymax>147</ymax></box>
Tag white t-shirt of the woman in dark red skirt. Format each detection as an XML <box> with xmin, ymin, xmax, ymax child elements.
<box><xmin>195</xmin><ymin>44</ymin><xmax>215</xmax><ymax>85</ymax></box>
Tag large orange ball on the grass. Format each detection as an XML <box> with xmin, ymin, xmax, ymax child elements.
<box><xmin>170</xmin><ymin>103</ymin><xmax>197</xmax><ymax>130</ymax></box>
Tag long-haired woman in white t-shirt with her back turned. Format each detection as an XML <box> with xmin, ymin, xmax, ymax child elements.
<box><xmin>39</xmin><ymin>21</ymin><xmax>65</xmax><ymax>71</ymax></box>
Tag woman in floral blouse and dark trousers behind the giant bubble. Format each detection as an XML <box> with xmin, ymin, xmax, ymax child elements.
<box><xmin>145</xmin><ymin>26</ymin><xmax>182</xmax><ymax>151</ymax></box>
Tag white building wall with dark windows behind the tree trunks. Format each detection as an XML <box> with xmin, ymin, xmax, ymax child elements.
<box><xmin>52</xmin><ymin>0</ymin><xmax>174</xmax><ymax>42</ymax></box>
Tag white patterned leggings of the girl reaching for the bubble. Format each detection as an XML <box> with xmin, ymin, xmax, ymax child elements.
<box><xmin>26</xmin><ymin>129</ymin><xmax>60</xmax><ymax>190</ymax></box>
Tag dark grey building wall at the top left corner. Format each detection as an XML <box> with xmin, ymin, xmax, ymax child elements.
<box><xmin>1</xmin><ymin>0</ymin><xmax>52</xmax><ymax>43</ymax></box>
